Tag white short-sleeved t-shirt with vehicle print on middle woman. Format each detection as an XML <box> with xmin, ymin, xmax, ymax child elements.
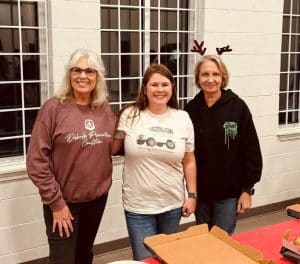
<box><xmin>115</xmin><ymin>107</ymin><xmax>194</xmax><ymax>214</ymax></box>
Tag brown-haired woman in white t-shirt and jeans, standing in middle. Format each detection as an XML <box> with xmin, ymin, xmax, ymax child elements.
<box><xmin>113</xmin><ymin>64</ymin><xmax>197</xmax><ymax>260</ymax></box>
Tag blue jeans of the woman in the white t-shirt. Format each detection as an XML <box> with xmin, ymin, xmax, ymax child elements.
<box><xmin>125</xmin><ymin>207</ymin><xmax>181</xmax><ymax>260</ymax></box>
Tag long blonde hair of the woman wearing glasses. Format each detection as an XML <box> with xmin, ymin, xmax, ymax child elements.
<box><xmin>56</xmin><ymin>49</ymin><xmax>108</xmax><ymax>108</ymax></box>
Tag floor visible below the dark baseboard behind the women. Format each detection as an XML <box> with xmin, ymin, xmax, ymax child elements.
<box><xmin>93</xmin><ymin>210</ymin><xmax>291</xmax><ymax>264</ymax></box>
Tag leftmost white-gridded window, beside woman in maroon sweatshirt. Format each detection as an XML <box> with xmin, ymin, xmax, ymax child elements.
<box><xmin>0</xmin><ymin>0</ymin><xmax>48</xmax><ymax>173</ymax></box>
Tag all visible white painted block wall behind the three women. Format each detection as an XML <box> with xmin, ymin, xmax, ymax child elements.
<box><xmin>0</xmin><ymin>0</ymin><xmax>300</xmax><ymax>264</ymax></box>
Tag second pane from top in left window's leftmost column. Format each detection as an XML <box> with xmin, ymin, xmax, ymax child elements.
<box><xmin>0</xmin><ymin>28</ymin><xmax>20</xmax><ymax>52</ymax></box>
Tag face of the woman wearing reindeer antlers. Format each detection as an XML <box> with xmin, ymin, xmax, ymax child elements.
<box><xmin>198</xmin><ymin>60</ymin><xmax>223</xmax><ymax>96</ymax></box>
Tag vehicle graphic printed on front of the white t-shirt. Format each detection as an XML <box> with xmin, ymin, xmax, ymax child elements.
<box><xmin>136</xmin><ymin>127</ymin><xmax>175</xmax><ymax>149</ymax></box>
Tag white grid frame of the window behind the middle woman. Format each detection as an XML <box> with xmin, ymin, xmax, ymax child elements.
<box><xmin>100</xmin><ymin>0</ymin><xmax>198</xmax><ymax>111</ymax></box>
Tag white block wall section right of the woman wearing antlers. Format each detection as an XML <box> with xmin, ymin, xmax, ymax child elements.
<box><xmin>198</xmin><ymin>0</ymin><xmax>300</xmax><ymax>206</ymax></box>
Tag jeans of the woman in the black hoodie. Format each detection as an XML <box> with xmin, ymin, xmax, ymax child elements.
<box><xmin>195</xmin><ymin>198</ymin><xmax>238</xmax><ymax>235</ymax></box>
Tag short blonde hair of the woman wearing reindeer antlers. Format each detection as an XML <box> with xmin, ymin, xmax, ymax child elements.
<box><xmin>194</xmin><ymin>55</ymin><xmax>229</xmax><ymax>89</ymax></box>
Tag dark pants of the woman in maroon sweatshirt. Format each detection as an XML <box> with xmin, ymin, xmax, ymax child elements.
<box><xmin>43</xmin><ymin>195</ymin><xmax>107</xmax><ymax>264</ymax></box>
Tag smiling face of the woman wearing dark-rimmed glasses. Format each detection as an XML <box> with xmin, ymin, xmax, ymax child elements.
<box><xmin>70</xmin><ymin>57</ymin><xmax>97</xmax><ymax>101</ymax></box>
